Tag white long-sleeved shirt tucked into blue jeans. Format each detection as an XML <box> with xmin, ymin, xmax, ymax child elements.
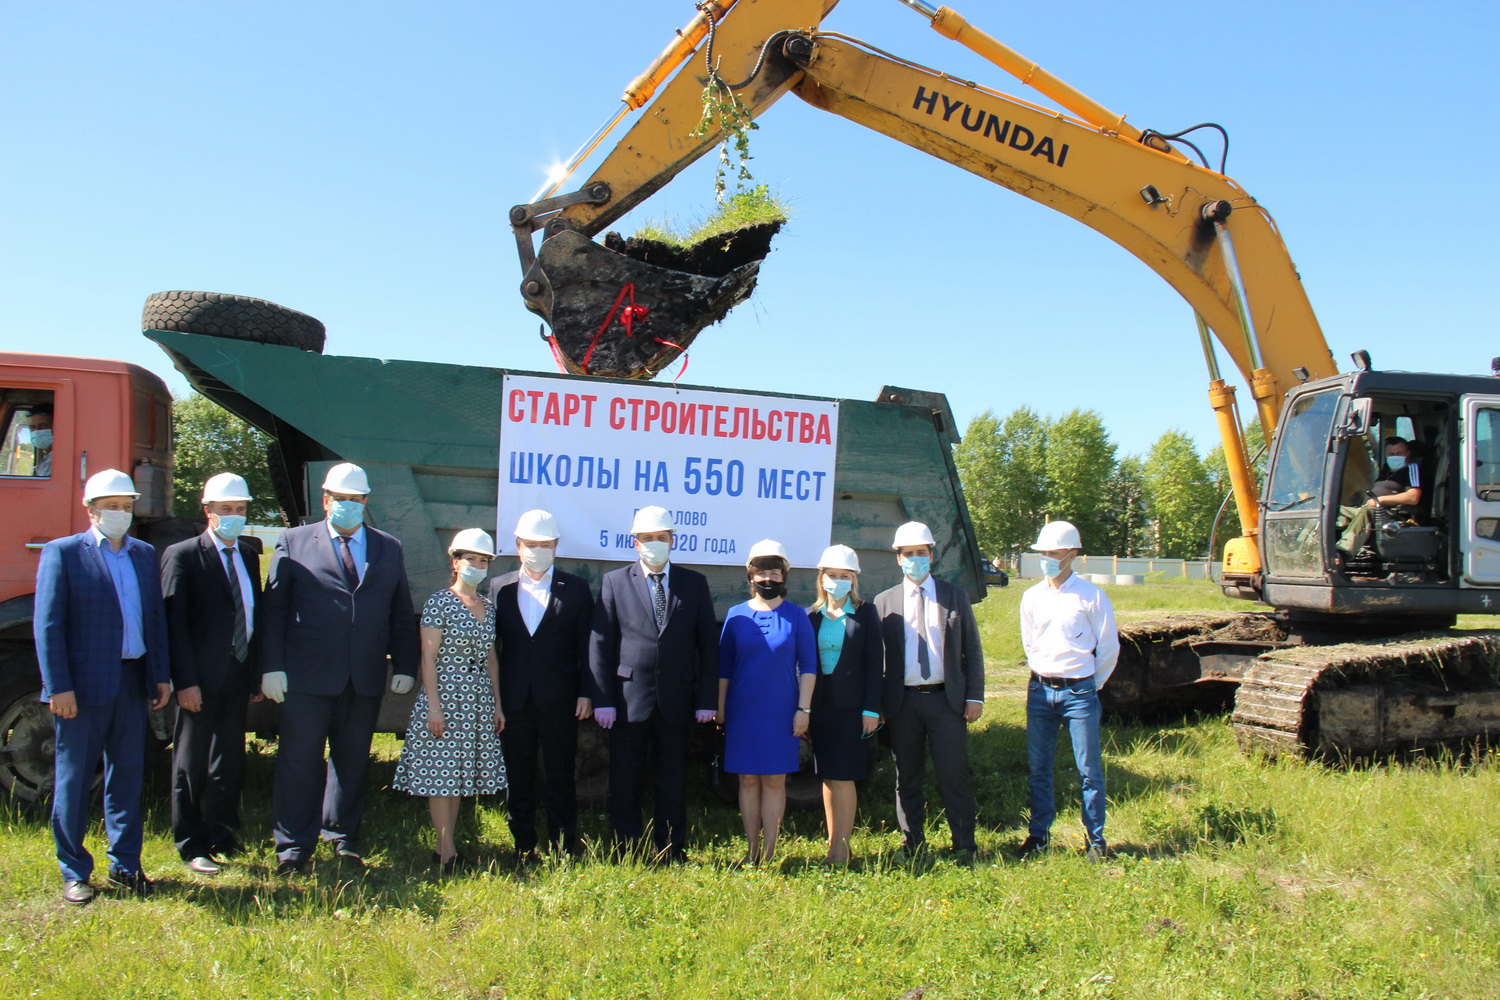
<box><xmin>1022</xmin><ymin>573</ymin><xmax>1121</xmax><ymax>688</ymax></box>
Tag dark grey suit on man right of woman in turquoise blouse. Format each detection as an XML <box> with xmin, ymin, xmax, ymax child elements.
<box><xmin>875</xmin><ymin>577</ymin><xmax>984</xmax><ymax>850</ymax></box>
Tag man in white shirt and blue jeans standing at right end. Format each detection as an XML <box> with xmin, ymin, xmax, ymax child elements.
<box><xmin>1022</xmin><ymin>520</ymin><xmax>1121</xmax><ymax>861</ymax></box>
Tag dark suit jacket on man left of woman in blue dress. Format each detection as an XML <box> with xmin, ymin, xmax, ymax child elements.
<box><xmin>588</xmin><ymin>562</ymin><xmax>719</xmax><ymax>723</ymax></box>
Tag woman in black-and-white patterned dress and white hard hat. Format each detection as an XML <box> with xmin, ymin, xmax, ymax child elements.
<box><xmin>395</xmin><ymin>528</ymin><xmax>506</xmax><ymax>871</ymax></box>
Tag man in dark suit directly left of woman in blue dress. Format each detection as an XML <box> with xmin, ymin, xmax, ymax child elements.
<box><xmin>588</xmin><ymin>507</ymin><xmax>719</xmax><ymax>861</ymax></box>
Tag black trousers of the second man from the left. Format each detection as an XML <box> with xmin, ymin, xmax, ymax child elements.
<box><xmin>173</xmin><ymin>684</ymin><xmax>251</xmax><ymax>861</ymax></box>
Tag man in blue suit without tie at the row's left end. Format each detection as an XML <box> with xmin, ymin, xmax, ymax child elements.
<box><xmin>35</xmin><ymin>469</ymin><xmax>173</xmax><ymax>906</ymax></box>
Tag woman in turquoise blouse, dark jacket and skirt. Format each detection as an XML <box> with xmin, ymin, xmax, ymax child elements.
<box><xmin>807</xmin><ymin>546</ymin><xmax>885</xmax><ymax>864</ymax></box>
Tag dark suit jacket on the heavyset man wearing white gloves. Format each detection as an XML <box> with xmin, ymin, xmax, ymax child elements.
<box><xmin>260</xmin><ymin>520</ymin><xmax>419</xmax><ymax>697</ymax></box>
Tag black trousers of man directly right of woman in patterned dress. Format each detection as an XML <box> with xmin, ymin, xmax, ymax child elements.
<box><xmin>500</xmin><ymin>696</ymin><xmax>578</xmax><ymax>853</ymax></box>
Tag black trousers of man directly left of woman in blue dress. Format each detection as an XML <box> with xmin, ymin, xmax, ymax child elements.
<box><xmin>609</xmin><ymin>709</ymin><xmax>693</xmax><ymax>850</ymax></box>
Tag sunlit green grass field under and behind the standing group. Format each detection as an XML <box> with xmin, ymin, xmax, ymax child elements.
<box><xmin>0</xmin><ymin>585</ymin><xmax>1500</xmax><ymax>1000</ymax></box>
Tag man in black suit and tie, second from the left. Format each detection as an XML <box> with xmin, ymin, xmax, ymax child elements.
<box><xmin>162</xmin><ymin>472</ymin><xmax>261</xmax><ymax>876</ymax></box>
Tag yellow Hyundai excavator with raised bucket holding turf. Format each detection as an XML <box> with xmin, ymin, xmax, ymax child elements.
<box><xmin>510</xmin><ymin>0</ymin><xmax>1500</xmax><ymax>754</ymax></box>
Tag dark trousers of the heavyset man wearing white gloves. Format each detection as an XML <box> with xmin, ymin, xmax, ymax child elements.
<box><xmin>272</xmin><ymin>685</ymin><xmax>380</xmax><ymax>861</ymax></box>
